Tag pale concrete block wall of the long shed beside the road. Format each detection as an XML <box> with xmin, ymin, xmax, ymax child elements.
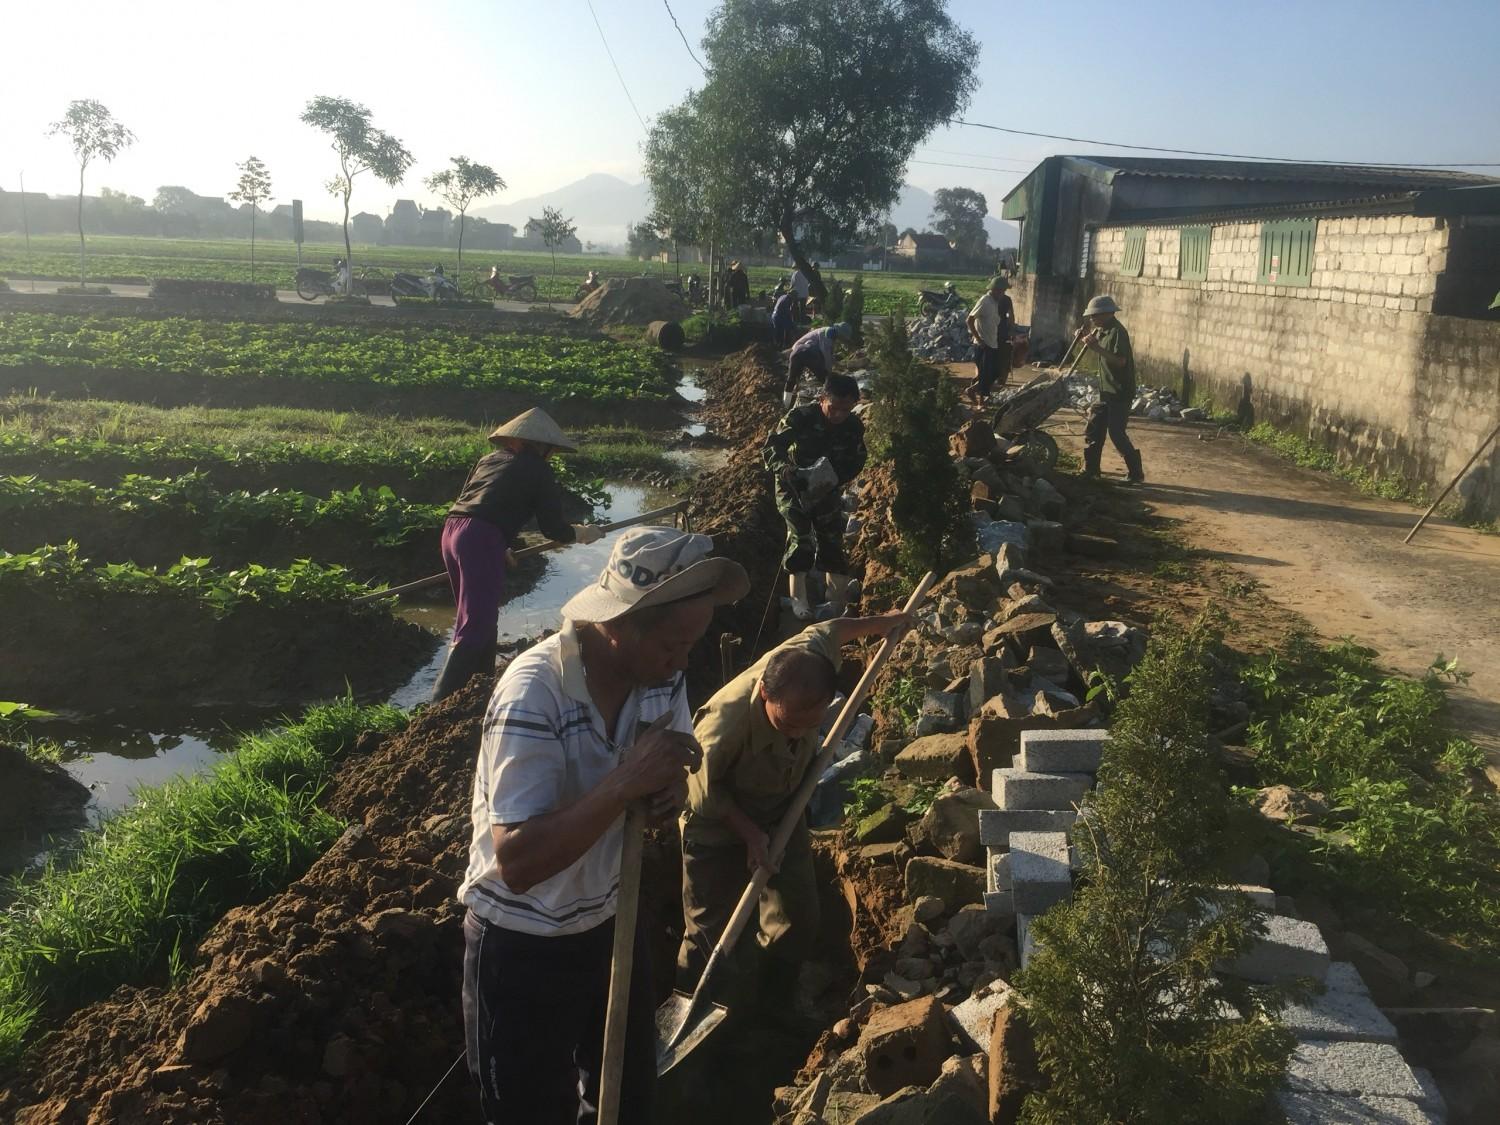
<box><xmin>1088</xmin><ymin>215</ymin><xmax>1500</xmax><ymax>516</ymax></box>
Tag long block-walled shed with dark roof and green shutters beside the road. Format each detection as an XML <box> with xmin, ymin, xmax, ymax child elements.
<box><xmin>1002</xmin><ymin>156</ymin><xmax>1500</xmax><ymax>516</ymax></box>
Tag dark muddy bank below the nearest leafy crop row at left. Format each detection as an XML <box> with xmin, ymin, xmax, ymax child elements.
<box><xmin>0</xmin><ymin>588</ymin><xmax>438</xmax><ymax>716</ymax></box>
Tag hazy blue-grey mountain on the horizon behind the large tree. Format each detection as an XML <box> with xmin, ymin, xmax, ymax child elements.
<box><xmin>474</xmin><ymin>173</ymin><xmax>1016</xmax><ymax>248</ymax></box>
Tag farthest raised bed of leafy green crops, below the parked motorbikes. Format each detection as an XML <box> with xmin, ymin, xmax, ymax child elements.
<box><xmin>0</xmin><ymin>312</ymin><xmax>677</xmax><ymax>401</ymax></box>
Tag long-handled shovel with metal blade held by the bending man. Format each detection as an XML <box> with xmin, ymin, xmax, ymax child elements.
<box><xmin>656</xmin><ymin>572</ymin><xmax>935</xmax><ymax>1076</ymax></box>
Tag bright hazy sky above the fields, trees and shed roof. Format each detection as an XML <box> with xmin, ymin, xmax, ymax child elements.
<box><xmin>0</xmin><ymin>0</ymin><xmax>1500</xmax><ymax>225</ymax></box>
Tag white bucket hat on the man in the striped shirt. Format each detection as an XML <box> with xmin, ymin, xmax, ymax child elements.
<box><xmin>563</xmin><ymin>527</ymin><xmax>750</xmax><ymax>621</ymax></box>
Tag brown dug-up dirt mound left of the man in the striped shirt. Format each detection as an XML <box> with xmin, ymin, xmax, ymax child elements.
<box><xmin>0</xmin><ymin>678</ymin><xmax>492</xmax><ymax>1125</ymax></box>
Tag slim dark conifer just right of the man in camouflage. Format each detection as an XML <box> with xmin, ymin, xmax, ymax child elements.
<box><xmin>861</xmin><ymin>319</ymin><xmax>974</xmax><ymax>575</ymax></box>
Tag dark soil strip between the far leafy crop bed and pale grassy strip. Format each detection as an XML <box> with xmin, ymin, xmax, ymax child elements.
<box><xmin>0</xmin><ymin>365</ymin><xmax>687</xmax><ymax>426</ymax></box>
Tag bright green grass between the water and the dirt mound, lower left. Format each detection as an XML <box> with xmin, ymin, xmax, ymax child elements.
<box><xmin>0</xmin><ymin>698</ymin><xmax>407</xmax><ymax>1065</ymax></box>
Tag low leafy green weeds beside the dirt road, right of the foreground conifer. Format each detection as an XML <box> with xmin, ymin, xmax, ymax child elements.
<box><xmin>1244</xmin><ymin>635</ymin><xmax>1500</xmax><ymax>954</ymax></box>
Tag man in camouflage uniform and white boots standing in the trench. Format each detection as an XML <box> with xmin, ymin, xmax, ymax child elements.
<box><xmin>761</xmin><ymin>375</ymin><xmax>866</xmax><ymax>621</ymax></box>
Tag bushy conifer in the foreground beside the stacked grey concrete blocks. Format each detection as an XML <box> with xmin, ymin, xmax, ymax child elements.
<box><xmin>1017</xmin><ymin>618</ymin><xmax>1293</xmax><ymax>1125</ymax></box>
